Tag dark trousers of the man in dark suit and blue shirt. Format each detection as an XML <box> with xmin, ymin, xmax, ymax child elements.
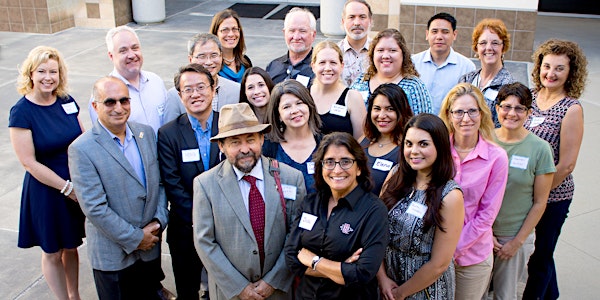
<box><xmin>167</xmin><ymin>218</ymin><xmax>202</xmax><ymax>300</ymax></box>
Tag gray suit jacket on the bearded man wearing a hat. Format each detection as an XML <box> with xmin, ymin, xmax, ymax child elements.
<box><xmin>192</xmin><ymin>156</ymin><xmax>306</xmax><ymax>300</ymax></box>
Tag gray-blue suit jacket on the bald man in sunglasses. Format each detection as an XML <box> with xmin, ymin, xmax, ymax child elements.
<box><xmin>69</xmin><ymin>121</ymin><xmax>168</xmax><ymax>271</ymax></box>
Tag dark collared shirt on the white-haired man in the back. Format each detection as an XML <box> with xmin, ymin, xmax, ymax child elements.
<box><xmin>266</xmin><ymin>48</ymin><xmax>315</xmax><ymax>87</ymax></box>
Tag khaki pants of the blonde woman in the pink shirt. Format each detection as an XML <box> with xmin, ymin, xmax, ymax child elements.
<box><xmin>454</xmin><ymin>253</ymin><xmax>494</xmax><ymax>300</ymax></box>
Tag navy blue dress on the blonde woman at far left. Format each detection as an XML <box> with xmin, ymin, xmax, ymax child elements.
<box><xmin>8</xmin><ymin>96</ymin><xmax>85</xmax><ymax>253</ymax></box>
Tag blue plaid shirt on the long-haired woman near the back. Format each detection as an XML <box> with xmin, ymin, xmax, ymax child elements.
<box><xmin>350</xmin><ymin>74</ymin><xmax>431</xmax><ymax>116</ymax></box>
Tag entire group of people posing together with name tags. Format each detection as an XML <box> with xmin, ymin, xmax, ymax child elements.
<box><xmin>9</xmin><ymin>0</ymin><xmax>587</xmax><ymax>300</ymax></box>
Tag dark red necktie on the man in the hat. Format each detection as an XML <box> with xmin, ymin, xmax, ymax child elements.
<box><xmin>243</xmin><ymin>175</ymin><xmax>265</xmax><ymax>268</ymax></box>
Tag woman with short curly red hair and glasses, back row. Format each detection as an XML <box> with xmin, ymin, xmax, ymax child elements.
<box><xmin>458</xmin><ymin>19</ymin><xmax>515</xmax><ymax>128</ymax></box>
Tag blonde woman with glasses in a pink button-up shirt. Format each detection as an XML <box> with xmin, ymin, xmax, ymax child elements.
<box><xmin>440</xmin><ymin>83</ymin><xmax>508</xmax><ymax>299</ymax></box>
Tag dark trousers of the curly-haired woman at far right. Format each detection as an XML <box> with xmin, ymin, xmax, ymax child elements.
<box><xmin>523</xmin><ymin>200</ymin><xmax>571</xmax><ymax>300</ymax></box>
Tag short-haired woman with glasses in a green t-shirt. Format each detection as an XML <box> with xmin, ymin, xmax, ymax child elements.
<box><xmin>492</xmin><ymin>82</ymin><xmax>556</xmax><ymax>299</ymax></box>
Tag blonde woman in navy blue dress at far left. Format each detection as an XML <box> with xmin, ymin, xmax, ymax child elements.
<box><xmin>8</xmin><ymin>46</ymin><xmax>85</xmax><ymax>299</ymax></box>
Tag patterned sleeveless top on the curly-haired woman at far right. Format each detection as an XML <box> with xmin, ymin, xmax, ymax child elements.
<box><xmin>525</xmin><ymin>91</ymin><xmax>580</xmax><ymax>203</ymax></box>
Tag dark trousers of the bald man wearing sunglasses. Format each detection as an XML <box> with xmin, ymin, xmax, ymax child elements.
<box><xmin>94</xmin><ymin>257</ymin><xmax>165</xmax><ymax>300</ymax></box>
